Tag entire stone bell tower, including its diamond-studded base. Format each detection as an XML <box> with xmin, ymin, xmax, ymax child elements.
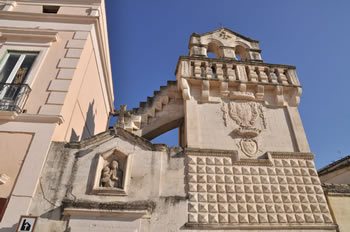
<box><xmin>176</xmin><ymin>28</ymin><xmax>336</xmax><ymax>231</ymax></box>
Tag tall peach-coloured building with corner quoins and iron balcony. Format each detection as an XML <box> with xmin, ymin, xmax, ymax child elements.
<box><xmin>0</xmin><ymin>0</ymin><xmax>113</xmax><ymax>231</ymax></box>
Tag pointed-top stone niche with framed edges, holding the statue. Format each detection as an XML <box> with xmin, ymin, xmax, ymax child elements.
<box><xmin>91</xmin><ymin>149</ymin><xmax>132</xmax><ymax>196</ymax></box>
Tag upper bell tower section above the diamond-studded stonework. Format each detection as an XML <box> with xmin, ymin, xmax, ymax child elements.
<box><xmin>176</xmin><ymin>28</ymin><xmax>310</xmax><ymax>158</ymax></box>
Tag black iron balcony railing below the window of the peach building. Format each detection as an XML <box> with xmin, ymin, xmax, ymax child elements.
<box><xmin>0</xmin><ymin>83</ymin><xmax>31</xmax><ymax>113</ymax></box>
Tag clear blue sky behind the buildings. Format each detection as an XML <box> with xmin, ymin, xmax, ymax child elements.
<box><xmin>106</xmin><ymin>0</ymin><xmax>350</xmax><ymax>168</ymax></box>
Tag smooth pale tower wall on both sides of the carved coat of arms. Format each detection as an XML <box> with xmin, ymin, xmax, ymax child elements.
<box><xmin>186</xmin><ymin>90</ymin><xmax>310</xmax><ymax>157</ymax></box>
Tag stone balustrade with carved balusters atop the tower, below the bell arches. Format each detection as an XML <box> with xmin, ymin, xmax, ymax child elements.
<box><xmin>176</xmin><ymin>56</ymin><xmax>300</xmax><ymax>86</ymax></box>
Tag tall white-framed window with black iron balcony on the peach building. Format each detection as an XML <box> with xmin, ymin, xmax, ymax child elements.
<box><xmin>0</xmin><ymin>51</ymin><xmax>38</xmax><ymax>112</ymax></box>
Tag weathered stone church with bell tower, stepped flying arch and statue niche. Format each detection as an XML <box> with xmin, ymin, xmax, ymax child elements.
<box><xmin>22</xmin><ymin>28</ymin><xmax>338</xmax><ymax>232</ymax></box>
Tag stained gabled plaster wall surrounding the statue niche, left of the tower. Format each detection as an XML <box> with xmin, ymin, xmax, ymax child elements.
<box><xmin>30</xmin><ymin>133</ymin><xmax>187</xmax><ymax>231</ymax></box>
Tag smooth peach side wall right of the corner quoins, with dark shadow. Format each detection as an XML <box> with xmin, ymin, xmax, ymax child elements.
<box><xmin>53</xmin><ymin>34</ymin><xmax>111</xmax><ymax>141</ymax></box>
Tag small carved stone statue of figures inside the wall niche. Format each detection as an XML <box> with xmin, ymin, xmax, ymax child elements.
<box><xmin>100</xmin><ymin>160</ymin><xmax>123</xmax><ymax>188</ymax></box>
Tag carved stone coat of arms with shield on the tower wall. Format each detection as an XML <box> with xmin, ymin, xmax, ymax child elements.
<box><xmin>221</xmin><ymin>101</ymin><xmax>266</xmax><ymax>157</ymax></box>
